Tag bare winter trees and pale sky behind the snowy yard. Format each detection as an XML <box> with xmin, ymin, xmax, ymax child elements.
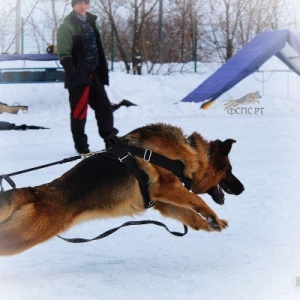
<box><xmin>0</xmin><ymin>0</ymin><xmax>297</xmax><ymax>74</ymax></box>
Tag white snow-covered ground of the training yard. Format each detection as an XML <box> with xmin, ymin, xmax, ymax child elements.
<box><xmin>0</xmin><ymin>59</ymin><xmax>300</xmax><ymax>300</ymax></box>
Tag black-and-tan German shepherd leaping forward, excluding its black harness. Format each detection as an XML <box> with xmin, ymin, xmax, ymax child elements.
<box><xmin>0</xmin><ymin>123</ymin><xmax>244</xmax><ymax>255</ymax></box>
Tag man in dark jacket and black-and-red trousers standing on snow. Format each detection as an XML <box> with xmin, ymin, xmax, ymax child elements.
<box><xmin>57</xmin><ymin>0</ymin><xmax>118</xmax><ymax>154</ymax></box>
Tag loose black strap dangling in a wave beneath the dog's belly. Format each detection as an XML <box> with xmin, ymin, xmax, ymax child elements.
<box><xmin>58</xmin><ymin>220</ymin><xmax>188</xmax><ymax>244</ymax></box>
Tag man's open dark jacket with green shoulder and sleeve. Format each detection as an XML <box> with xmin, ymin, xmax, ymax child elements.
<box><xmin>57</xmin><ymin>11</ymin><xmax>109</xmax><ymax>88</ymax></box>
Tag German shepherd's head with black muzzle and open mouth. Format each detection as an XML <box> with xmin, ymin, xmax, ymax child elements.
<box><xmin>192</xmin><ymin>134</ymin><xmax>244</xmax><ymax>204</ymax></box>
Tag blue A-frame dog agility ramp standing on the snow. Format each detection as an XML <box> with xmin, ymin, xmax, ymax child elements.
<box><xmin>181</xmin><ymin>30</ymin><xmax>300</xmax><ymax>107</ymax></box>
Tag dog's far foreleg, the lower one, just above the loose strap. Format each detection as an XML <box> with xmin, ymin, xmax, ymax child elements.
<box><xmin>153</xmin><ymin>201</ymin><xmax>227</xmax><ymax>231</ymax></box>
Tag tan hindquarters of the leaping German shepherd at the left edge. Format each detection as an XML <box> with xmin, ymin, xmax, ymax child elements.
<box><xmin>0</xmin><ymin>188</ymin><xmax>73</xmax><ymax>255</ymax></box>
